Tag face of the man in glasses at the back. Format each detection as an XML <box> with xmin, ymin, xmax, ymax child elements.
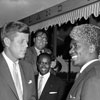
<box><xmin>34</xmin><ymin>34</ymin><xmax>47</xmax><ymax>50</ymax></box>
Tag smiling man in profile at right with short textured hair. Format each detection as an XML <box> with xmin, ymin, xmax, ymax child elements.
<box><xmin>66</xmin><ymin>24</ymin><xmax>100</xmax><ymax>100</ymax></box>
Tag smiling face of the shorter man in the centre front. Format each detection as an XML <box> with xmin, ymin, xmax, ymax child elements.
<box><xmin>38</xmin><ymin>56</ymin><xmax>50</xmax><ymax>75</ymax></box>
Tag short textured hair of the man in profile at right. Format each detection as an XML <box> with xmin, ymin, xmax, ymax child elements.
<box><xmin>70</xmin><ymin>24</ymin><xmax>100</xmax><ymax>52</ymax></box>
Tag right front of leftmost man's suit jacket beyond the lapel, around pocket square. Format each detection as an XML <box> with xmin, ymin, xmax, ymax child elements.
<box><xmin>21</xmin><ymin>60</ymin><xmax>36</xmax><ymax>100</ymax></box>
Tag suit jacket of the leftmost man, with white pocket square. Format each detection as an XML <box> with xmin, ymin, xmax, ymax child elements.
<box><xmin>0</xmin><ymin>54</ymin><xmax>36</xmax><ymax>100</ymax></box>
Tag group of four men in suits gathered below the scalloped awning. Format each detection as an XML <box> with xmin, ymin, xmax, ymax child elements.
<box><xmin>0</xmin><ymin>21</ymin><xmax>100</xmax><ymax>100</ymax></box>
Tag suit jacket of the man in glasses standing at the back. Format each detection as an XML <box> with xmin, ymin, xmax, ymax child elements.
<box><xmin>24</xmin><ymin>46</ymin><xmax>51</xmax><ymax>74</ymax></box>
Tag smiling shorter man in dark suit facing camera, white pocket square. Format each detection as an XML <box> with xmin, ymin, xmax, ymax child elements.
<box><xmin>36</xmin><ymin>53</ymin><xmax>65</xmax><ymax>100</ymax></box>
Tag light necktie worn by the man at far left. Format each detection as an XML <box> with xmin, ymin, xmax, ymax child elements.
<box><xmin>13</xmin><ymin>63</ymin><xmax>23</xmax><ymax>100</ymax></box>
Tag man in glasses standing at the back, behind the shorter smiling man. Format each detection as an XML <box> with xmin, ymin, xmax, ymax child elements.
<box><xmin>24</xmin><ymin>30</ymin><xmax>51</xmax><ymax>74</ymax></box>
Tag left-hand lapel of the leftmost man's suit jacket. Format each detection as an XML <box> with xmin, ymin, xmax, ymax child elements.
<box><xmin>0</xmin><ymin>55</ymin><xmax>18</xmax><ymax>98</ymax></box>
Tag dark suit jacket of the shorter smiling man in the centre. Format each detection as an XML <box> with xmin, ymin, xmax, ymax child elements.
<box><xmin>36</xmin><ymin>74</ymin><xmax>66</xmax><ymax>100</ymax></box>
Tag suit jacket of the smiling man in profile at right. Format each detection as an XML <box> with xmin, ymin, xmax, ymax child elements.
<box><xmin>66</xmin><ymin>61</ymin><xmax>100</xmax><ymax>100</ymax></box>
